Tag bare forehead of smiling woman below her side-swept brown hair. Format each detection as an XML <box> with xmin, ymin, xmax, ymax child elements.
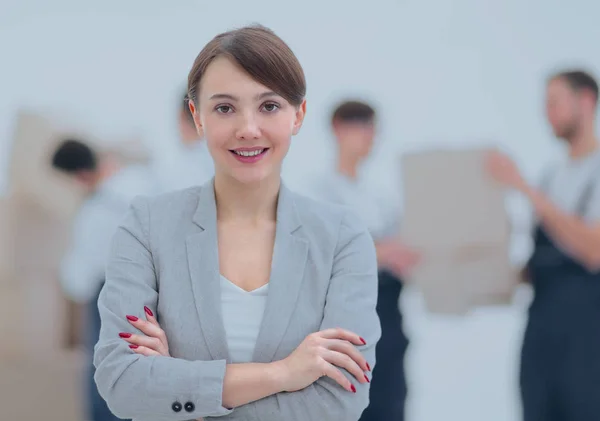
<box><xmin>200</xmin><ymin>56</ymin><xmax>269</xmax><ymax>97</ymax></box>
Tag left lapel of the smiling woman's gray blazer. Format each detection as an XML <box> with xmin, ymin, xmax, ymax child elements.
<box><xmin>186</xmin><ymin>180</ymin><xmax>230</xmax><ymax>362</ymax></box>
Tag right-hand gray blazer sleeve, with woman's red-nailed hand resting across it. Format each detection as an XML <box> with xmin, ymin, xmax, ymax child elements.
<box><xmin>251</xmin><ymin>212</ymin><xmax>381</xmax><ymax>421</ymax></box>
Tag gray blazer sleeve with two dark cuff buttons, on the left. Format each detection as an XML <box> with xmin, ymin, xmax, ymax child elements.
<box><xmin>94</xmin><ymin>198</ymin><xmax>231</xmax><ymax>421</ymax></box>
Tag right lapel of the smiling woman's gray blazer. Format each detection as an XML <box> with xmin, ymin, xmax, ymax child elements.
<box><xmin>253</xmin><ymin>184</ymin><xmax>308</xmax><ymax>363</ymax></box>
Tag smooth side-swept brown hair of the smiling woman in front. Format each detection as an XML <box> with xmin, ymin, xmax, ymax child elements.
<box><xmin>188</xmin><ymin>25</ymin><xmax>306</xmax><ymax>106</ymax></box>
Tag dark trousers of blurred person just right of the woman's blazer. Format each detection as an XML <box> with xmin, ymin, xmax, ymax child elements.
<box><xmin>360</xmin><ymin>272</ymin><xmax>408</xmax><ymax>421</ymax></box>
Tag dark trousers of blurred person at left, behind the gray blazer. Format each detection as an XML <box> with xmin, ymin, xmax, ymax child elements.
<box><xmin>84</xmin><ymin>284</ymin><xmax>127</xmax><ymax>421</ymax></box>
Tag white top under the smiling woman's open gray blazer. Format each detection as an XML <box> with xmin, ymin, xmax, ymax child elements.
<box><xmin>221</xmin><ymin>275</ymin><xmax>269</xmax><ymax>363</ymax></box>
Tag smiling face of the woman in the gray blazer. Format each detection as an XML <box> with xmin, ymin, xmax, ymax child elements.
<box><xmin>190</xmin><ymin>57</ymin><xmax>306</xmax><ymax>184</ymax></box>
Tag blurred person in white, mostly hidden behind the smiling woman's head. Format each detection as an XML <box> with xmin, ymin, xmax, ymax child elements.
<box><xmin>162</xmin><ymin>94</ymin><xmax>215</xmax><ymax>191</ymax></box>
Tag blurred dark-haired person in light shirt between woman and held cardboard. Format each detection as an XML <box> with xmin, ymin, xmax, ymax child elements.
<box><xmin>308</xmin><ymin>101</ymin><xmax>418</xmax><ymax>421</ymax></box>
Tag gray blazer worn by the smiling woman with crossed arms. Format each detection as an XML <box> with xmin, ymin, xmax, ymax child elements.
<box><xmin>94</xmin><ymin>180</ymin><xmax>381</xmax><ymax>421</ymax></box>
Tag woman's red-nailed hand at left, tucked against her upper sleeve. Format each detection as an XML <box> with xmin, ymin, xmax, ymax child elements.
<box><xmin>119</xmin><ymin>307</ymin><xmax>170</xmax><ymax>357</ymax></box>
